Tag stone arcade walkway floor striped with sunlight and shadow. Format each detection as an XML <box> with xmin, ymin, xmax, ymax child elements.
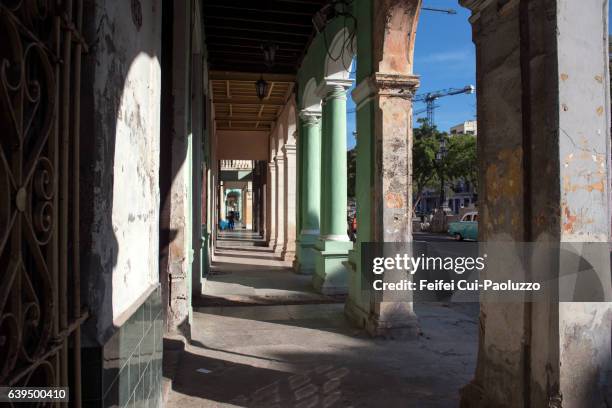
<box><xmin>167</xmin><ymin>232</ymin><xmax>478</xmax><ymax>408</ymax></box>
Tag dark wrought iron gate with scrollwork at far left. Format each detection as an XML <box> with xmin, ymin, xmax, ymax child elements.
<box><xmin>0</xmin><ymin>0</ymin><xmax>87</xmax><ymax>406</ymax></box>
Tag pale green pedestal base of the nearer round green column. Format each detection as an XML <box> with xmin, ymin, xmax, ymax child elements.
<box><xmin>312</xmin><ymin>240</ymin><xmax>353</xmax><ymax>295</ymax></box>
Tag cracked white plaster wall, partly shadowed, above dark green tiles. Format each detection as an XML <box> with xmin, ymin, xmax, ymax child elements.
<box><xmin>81</xmin><ymin>0</ymin><xmax>161</xmax><ymax>342</ymax></box>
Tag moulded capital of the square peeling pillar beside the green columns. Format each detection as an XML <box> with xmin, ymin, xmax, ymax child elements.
<box><xmin>353</xmin><ymin>72</ymin><xmax>420</xmax><ymax>108</ymax></box>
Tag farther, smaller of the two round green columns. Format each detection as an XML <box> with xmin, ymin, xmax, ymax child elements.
<box><xmin>296</xmin><ymin>111</ymin><xmax>321</xmax><ymax>274</ymax></box>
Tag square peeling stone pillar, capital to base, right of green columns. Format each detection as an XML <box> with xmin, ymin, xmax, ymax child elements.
<box><xmin>346</xmin><ymin>73</ymin><xmax>419</xmax><ymax>335</ymax></box>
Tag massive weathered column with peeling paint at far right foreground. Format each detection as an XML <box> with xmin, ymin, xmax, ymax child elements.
<box><xmin>461</xmin><ymin>0</ymin><xmax>612</xmax><ymax>407</ymax></box>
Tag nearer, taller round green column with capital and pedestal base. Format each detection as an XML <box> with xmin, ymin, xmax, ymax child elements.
<box><xmin>313</xmin><ymin>79</ymin><xmax>353</xmax><ymax>294</ymax></box>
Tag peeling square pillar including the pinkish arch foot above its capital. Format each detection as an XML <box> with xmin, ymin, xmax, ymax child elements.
<box><xmin>345</xmin><ymin>0</ymin><xmax>420</xmax><ymax>336</ymax></box>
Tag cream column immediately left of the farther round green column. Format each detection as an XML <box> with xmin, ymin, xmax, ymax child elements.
<box><xmin>282</xmin><ymin>142</ymin><xmax>297</xmax><ymax>262</ymax></box>
